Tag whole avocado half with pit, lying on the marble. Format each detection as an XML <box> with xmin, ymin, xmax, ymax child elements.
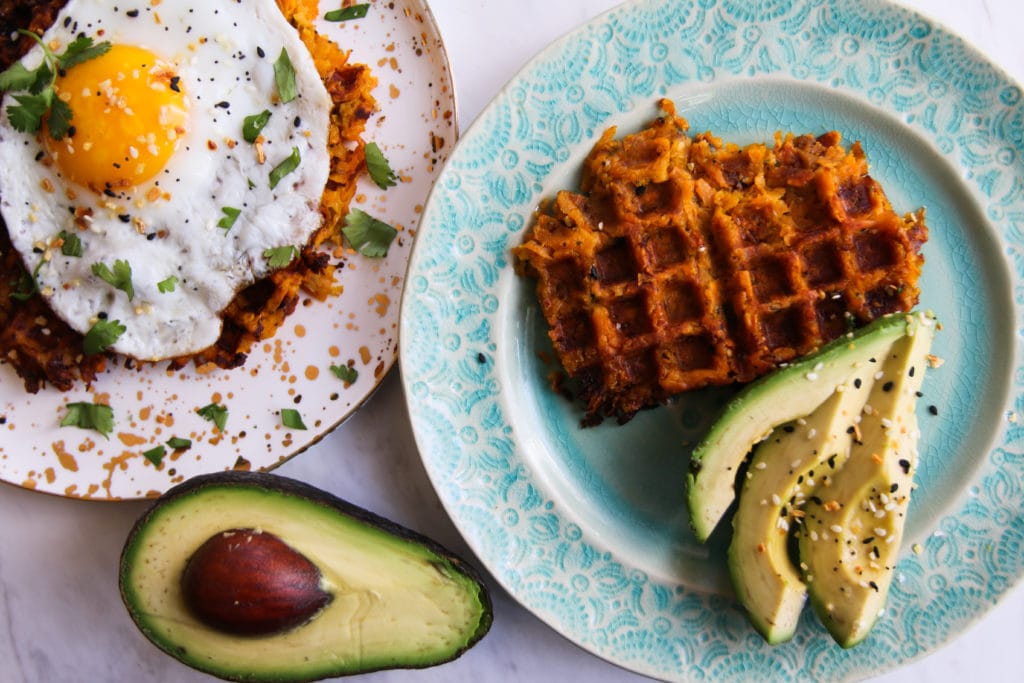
<box><xmin>119</xmin><ymin>472</ymin><xmax>493</xmax><ymax>681</ymax></box>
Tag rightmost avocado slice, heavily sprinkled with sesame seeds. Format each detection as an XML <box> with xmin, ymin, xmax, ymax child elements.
<box><xmin>799</xmin><ymin>317</ymin><xmax>935</xmax><ymax>647</ymax></box>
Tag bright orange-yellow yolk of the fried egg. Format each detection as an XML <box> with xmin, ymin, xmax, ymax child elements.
<box><xmin>43</xmin><ymin>45</ymin><xmax>188</xmax><ymax>193</ymax></box>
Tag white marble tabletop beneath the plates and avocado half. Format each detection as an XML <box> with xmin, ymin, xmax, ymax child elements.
<box><xmin>0</xmin><ymin>0</ymin><xmax>1024</xmax><ymax>683</ymax></box>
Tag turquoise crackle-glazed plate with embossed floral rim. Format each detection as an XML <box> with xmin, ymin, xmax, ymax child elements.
<box><xmin>400</xmin><ymin>0</ymin><xmax>1024</xmax><ymax>681</ymax></box>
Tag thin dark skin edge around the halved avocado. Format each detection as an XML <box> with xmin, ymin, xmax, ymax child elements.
<box><xmin>118</xmin><ymin>471</ymin><xmax>494</xmax><ymax>683</ymax></box>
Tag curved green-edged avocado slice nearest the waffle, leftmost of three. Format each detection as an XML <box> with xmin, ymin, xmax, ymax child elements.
<box><xmin>686</xmin><ymin>313</ymin><xmax>910</xmax><ymax>543</ymax></box>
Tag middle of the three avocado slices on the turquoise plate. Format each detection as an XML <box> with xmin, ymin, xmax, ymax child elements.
<box><xmin>728</xmin><ymin>362</ymin><xmax>877</xmax><ymax>644</ymax></box>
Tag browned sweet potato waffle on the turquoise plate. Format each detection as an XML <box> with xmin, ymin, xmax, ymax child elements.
<box><xmin>513</xmin><ymin>100</ymin><xmax>928</xmax><ymax>423</ymax></box>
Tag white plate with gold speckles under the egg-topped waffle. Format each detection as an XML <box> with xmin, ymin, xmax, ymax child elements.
<box><xmin>0</xmin><ymin>0</ymin><xmax>456</xmax><ymax>500</ymax></box>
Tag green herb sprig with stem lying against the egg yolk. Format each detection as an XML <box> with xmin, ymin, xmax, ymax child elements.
<box><xmin>0</xmin><ymin>31</ymin><xmax>111</xmax><ymax>140</ymax></box>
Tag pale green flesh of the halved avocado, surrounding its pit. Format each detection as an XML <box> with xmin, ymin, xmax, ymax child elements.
<box><xmin>120</xmin><ymin>473</ymin><xmax>492</xmax><ymax>681</ymax></box>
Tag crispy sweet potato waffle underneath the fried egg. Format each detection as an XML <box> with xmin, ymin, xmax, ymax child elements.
<box><xmin>0</xmin><ymin>0</ymin><xmax>376</xmax><ymax>393</ymax></box>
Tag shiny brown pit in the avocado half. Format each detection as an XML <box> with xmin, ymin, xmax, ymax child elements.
<box><xmin>181</xmin><ymin>528</ymin><xmax>332</xmax><ymax>636</ymax></box>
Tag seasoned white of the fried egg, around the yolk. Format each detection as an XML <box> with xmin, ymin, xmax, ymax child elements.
<box><xmin>0</xmin><ymin>0</ymin><xmax>331</xmax><ymax>360</ymax></box>
